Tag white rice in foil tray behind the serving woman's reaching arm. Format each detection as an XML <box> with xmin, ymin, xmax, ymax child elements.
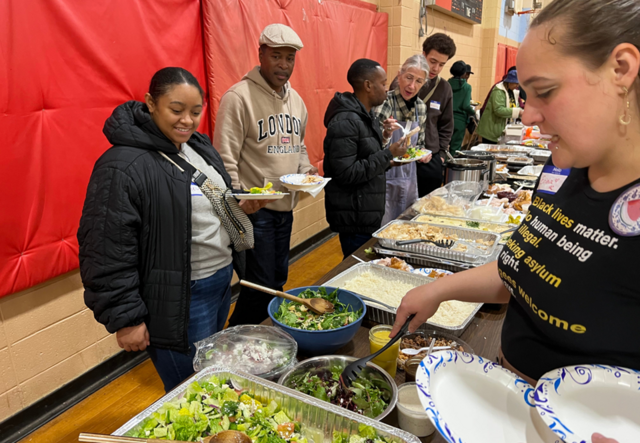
<box><xmin>342</xmin><ymin>272</ymin><xmax>477</xmax><ymax>327</ymax></box>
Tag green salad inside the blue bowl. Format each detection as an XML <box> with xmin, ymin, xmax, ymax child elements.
<box><xmin>274</xmin><ymin>288</ymin><xmax>362</xmax><ymax>331</ymax></box>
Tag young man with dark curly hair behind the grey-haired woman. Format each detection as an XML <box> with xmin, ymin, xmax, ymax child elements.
<box><xmin>389</xmin><ymin>33</ymin><xmax>456</xmax><ymax>197</ymax></box>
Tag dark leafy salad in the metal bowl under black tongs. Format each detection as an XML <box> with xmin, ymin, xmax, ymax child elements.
<box><xmin>287</xmin><ymin>366</ymin><xmax>391</xmax><ymax>418</ymax></box>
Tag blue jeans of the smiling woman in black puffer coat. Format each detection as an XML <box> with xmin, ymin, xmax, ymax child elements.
<box><xmin>147</xmin><ymin>265</ymin><xmax>233</xmax><ymax>392</ymax></box>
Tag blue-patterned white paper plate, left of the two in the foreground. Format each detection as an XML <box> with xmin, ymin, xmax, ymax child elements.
<box><xmin>416</xmin><ymin>351</ymin><xmax>560</xmax><ymax>443</ymax></box>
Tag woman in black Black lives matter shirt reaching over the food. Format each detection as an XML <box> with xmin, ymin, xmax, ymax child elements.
<box><xmin>391</xmin><ymin>0</ymin><xmax>640</xmax><ymax>443</ymax></box>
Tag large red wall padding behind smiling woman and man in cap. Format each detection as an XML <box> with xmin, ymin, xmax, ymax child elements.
<box><xmin>0</xmin><ymin>0</ymin><xmax>387</xmax><ymax>297</ymax></box>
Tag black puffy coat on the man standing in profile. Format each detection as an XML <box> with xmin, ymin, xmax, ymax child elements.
<box><xmin>324</xmin><ymin>92</ymin><xmax>393</xmax><ymax>234</ymax></box>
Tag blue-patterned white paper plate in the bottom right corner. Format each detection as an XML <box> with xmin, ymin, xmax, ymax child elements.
<box><xmin>535</xmin><ymin>365</ymin><xmax>640</xmax><ymax>443</ymax></box>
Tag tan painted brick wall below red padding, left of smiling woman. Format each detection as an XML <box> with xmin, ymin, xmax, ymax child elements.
<box><xmin>0</xmin><ymin>271</ymin><xmax>120</xmax><ymax>421</ymax></box>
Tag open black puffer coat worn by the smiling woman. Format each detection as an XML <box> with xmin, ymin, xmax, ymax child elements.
<box><xmin>78</xmin><ymin>101</ymin><xmax>231</xmax><ymax>353</ymax></box>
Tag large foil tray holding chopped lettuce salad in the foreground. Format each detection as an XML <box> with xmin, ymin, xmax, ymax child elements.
<box><xmin>112</xmin><ymin>366</ymin><xmax>421</xmax><ymax>443</ymax></box>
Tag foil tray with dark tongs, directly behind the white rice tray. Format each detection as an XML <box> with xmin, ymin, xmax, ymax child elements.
<box><xmin>373</xmin><ymin>220</ymin><xmax>501</xmax><ymax>264</ymax></box>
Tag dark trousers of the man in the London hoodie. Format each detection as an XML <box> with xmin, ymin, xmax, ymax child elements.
<box><xmin>229</xmin><ymin>208</ymin><xmax>293</xmax><ymax>326</ymax></box>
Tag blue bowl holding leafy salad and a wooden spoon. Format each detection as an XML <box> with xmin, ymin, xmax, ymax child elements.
<box><xmin>269</xmin><ymin>286</ymin><xmax>367</xmax><ymax>357</ymax></box>
